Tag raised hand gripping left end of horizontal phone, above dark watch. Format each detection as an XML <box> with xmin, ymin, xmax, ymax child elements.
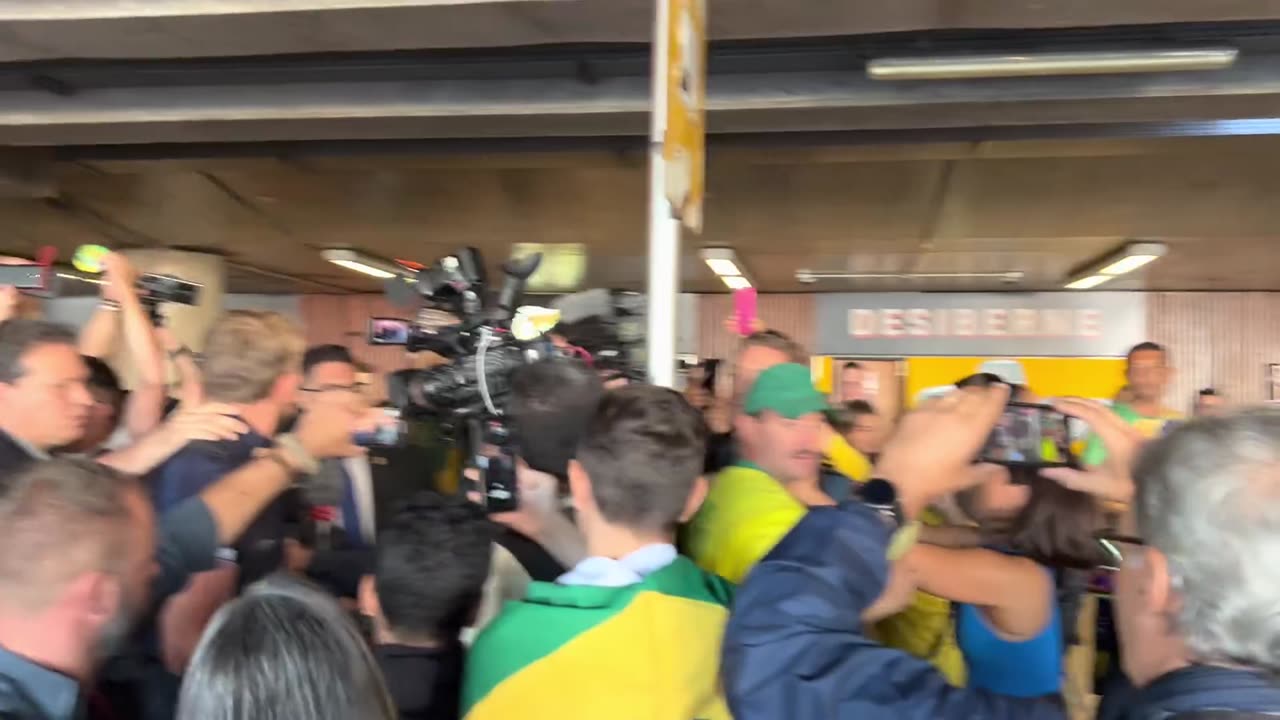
<box><xmin>874</xmin><ymin>384</ymin><xmax>1009</xmax><ymax>518</ymax></box>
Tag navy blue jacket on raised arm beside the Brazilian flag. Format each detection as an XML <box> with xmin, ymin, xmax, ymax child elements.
<box><xmin>722</xmin><ymin>502</ymin><xmax>1065</xmax><ymax>720</ymax></box>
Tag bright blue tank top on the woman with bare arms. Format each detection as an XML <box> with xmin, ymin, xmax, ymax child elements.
<box><xmin>956</xmin><ymin>561</ymin><xmax>1064</xmax><ymax>697</ymax></box>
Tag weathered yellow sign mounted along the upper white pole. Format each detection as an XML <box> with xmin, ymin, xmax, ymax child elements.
<box><xmin>659</xmin><ymin>0</ymin><xmax>707</xmax><ymax>233</ymax></box>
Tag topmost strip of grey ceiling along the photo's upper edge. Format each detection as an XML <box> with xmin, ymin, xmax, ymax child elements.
<box><xmin>0</xmin><ymin>0</ymin><xmax>1280</xmax><ymax>61</ymax></box>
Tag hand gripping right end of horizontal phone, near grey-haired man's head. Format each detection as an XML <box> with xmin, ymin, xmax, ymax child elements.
<box><xmin>1041</xmin><ymin>398</ymin><xmax>1146</xmax><ymax>503</ymax></box>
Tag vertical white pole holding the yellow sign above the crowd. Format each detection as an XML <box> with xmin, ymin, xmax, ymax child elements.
<box><xmin>646</xmin><ymin>0</ymin><xmax>680</xmax><ymax>387</ymax></box>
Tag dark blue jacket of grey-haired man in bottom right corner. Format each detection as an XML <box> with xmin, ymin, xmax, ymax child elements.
<box><xmin>1098</xmin><ymin>665</ymin><xmax>1280</xmax><ymax>720</ymax></box>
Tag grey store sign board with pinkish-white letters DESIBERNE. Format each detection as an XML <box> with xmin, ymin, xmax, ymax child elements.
<box><xmin>814</xmin><ymin>292</ymin><xmax>1147</xmax><ymax>357</ymax></box>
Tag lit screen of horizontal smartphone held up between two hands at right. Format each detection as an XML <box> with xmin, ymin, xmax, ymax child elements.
<box><xmin>978</xmin><ymin>402</ymin><xmax>1079</xmax><ymax>468</ymax></box>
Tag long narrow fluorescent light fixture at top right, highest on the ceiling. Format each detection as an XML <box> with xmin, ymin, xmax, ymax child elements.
<box><xmin>867</xmin><ymin>47</ymin><xmax>1240</xmax><ymax>81</ymax></box>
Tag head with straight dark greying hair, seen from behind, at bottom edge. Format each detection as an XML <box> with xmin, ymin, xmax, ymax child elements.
<box><xmin>178</xmin><ymin>575</ymin><xmax>397</xmax><ymax>720</ymax></box>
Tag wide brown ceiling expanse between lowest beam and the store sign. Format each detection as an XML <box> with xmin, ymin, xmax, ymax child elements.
<box><xmin>0</xmin><ymin>137</ymin><xmax>1280</xmax><ymax>292</ymax></box>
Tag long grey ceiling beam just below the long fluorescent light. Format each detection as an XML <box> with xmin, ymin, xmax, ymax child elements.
<box><xmin>0</xmin><ymin>55</ymin><xmax>1280</xmax><ymax>145</ymax></box>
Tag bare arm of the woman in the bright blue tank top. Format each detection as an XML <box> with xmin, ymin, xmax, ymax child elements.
<box><xmin>902</xmin><ymin>544</ymin><xmax>1053</xmax><ymax>638</ymax></box>
